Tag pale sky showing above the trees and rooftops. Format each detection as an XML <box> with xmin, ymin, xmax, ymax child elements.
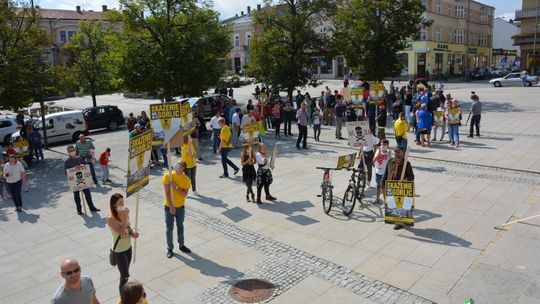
<box><xmin>34</xmin><ymin>0</ymin><xmax>522</xmax><ymax>20</ymax></box>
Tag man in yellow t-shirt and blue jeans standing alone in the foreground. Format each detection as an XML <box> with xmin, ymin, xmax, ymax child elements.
<box><xmin>162</xmin><ymin>161</ymin><xmax>191</xmax><ymax>259</ymax></box>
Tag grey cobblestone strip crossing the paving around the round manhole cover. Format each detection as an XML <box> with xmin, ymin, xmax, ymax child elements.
<box><xmin>141</xmin><ymin>190</ymin><xmax>433</xmax><ymax>304</ymax></box>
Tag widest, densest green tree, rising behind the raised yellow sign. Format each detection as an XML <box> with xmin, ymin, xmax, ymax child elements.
<box><xmin>117</xmin><ymin>0</ymin><xmax>231</xmax><ymax>99</ymax></box>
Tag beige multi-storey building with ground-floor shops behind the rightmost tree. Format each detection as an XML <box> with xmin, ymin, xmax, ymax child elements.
<box><xmin>400</xmin><ymin>0</ymin><xmax>495</xmax><ymax>78</ymax></box>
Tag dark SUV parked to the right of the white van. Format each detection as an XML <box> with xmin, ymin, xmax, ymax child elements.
<box><xmin>83</xmin><ymin>106</ymin><xmax>125</xmax><ymax>130</ymax></box>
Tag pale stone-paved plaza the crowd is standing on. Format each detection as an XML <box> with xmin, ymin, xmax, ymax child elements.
<box><xmin>0</xmin><ymin>81</ymin><xmax>540</xmax><ymax>304</ymax></box>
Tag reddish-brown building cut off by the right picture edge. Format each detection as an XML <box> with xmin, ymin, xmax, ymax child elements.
<box><xmin>512</xmin><ymin>0</ymin><xmax>540</xmax><ymax>75</ymax></box>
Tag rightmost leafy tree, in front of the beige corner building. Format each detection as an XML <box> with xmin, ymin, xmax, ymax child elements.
<box><xmin>334</xmin><ymin>0</ymin><xmax>432</xmax><ymax>81</ymax></box>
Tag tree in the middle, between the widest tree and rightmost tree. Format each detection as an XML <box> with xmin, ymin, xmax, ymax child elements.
<box><xmin>247</xmin><ymin>0</ymin><xmax>336</xmax><ymax>96</ymax></box>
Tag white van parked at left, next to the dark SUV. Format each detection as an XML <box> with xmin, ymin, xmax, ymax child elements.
<box><xmin>11</xmin><ymin>110</ymin><xmax>88</xmax><ymax>144</ymax></box>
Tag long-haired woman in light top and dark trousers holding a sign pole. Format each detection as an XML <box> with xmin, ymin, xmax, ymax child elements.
<box><xmin>107</xmin><ymin>193</ymin><xmax>139</xmax><ymax>291</ymax></box>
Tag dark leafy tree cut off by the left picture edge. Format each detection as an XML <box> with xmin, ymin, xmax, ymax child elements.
<box><xmin>0</xmin><ymin>1</ymin><xmax>50</xmax><ymax>110</ymax></box>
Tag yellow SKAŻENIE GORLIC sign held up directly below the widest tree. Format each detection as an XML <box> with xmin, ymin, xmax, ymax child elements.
<box><xmin>150</xmin><ymin>102</ymin><xmax>183</xmax><ymax>148</ymax></box>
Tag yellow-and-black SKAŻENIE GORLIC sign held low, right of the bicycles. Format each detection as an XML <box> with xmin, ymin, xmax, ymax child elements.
<box><xmin>384</xmin><ymin>180</ymin><xmax>414</xmax><ymax>225</ymax></box>
